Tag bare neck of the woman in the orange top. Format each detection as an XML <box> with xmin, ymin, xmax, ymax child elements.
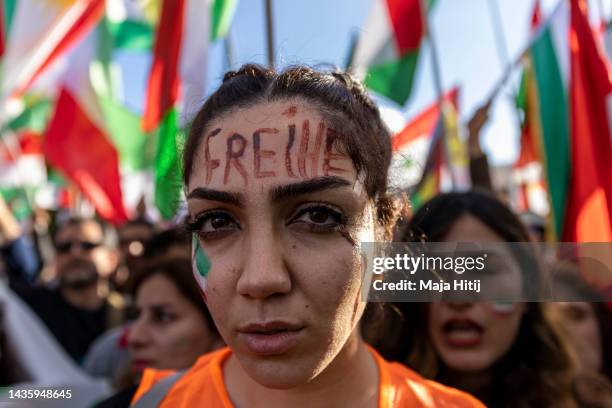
<box><xmin>224</xmin><ymin>334</ymin><xmax>380</xmax><ymax>408</ymax></box>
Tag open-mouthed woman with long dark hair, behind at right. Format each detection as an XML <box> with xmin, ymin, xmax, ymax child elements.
<box><xmin>376</xmin><ymin>191</ymin><xmax>612</xmax><ymax>407</ymax></box>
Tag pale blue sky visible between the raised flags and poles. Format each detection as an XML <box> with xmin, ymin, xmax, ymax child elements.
<box><xmin>118</xmin><ymin>0</ymin><xmax>610</xmax><ymax>164</ymax></box>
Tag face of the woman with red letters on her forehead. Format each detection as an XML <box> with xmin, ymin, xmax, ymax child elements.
<box><xmin>187</xmin><ymin>101</ymin><xmax>374</xmax><ymax>388</ymax></box>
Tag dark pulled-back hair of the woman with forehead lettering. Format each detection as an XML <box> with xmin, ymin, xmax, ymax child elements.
<box><xmin>183</xmin><ymin>64</ymin><xmax>399</xmax><ymax>236</ymax></box>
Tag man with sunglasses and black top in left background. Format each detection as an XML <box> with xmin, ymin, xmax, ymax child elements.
<box><xmin>11</xmin><ymin>218</ymin><xmax>125</xmax><ymax>363</ymax></box>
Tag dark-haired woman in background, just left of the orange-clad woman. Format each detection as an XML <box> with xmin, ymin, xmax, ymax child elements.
<box><xmin>98</xmin><ymin>257</ymin><xmax>223</xmax><ymax>408</ymax></box>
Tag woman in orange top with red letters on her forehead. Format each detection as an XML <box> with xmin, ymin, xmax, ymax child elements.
<box><xmin>133</xmin><ymin>65</ymin><xmax>482</xmax><ymax>407</ymax></box>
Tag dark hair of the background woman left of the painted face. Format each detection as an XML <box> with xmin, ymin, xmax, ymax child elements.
<box><xmin>131</xmin><ymin>257</ymin><xmax>218</xmax><ymax>335</ymax></box>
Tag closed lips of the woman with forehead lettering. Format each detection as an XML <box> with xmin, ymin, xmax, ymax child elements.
<box><xmin>238</xmin><ymin>322</ymin><xmax>304</xmax><ymax>356</ymax></box>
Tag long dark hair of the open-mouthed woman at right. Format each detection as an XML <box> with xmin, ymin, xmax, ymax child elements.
<box><xmin>374</xmin><ymin>191</ymin><xmax>575</xmax><ymax>407</ymax></box>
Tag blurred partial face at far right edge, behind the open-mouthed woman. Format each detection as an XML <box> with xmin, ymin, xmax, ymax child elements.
<box><xmin>551</xmin><ymin>302</ymin><xmax>603</xmax><ymax>372</ymax></box>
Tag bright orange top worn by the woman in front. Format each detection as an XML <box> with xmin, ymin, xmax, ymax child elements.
<box><xmin>132</xmin><ymin>348</ymin><xmax>484</xmax><ymax>408</ymax></box>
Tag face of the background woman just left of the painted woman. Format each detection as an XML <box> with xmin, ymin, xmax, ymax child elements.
<box><xmin>128</xmin><ymin>273</ymin><xmax>217</xmax><ymax>371</ymax></box>
